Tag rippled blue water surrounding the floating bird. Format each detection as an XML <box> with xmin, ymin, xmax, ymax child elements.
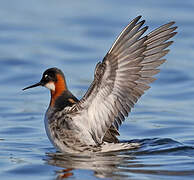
<box><xmin>0</xmin><ymin>0</ymin><xmax>194</xmax><ymax>180</ymax></box>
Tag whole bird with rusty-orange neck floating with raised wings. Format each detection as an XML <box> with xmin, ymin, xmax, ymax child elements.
<box><xmin>23</xmin><ymin>16</ymin><xmax>177</xmax><ymax>153</ymax></box>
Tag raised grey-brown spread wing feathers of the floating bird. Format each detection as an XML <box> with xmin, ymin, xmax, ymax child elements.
<box><xmin>73</xmin><ymin>16</ymin><xmax>177</xmax><ymax>144</ymax></box>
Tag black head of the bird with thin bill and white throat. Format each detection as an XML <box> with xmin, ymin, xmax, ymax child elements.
<box><xmin>23</xmin><ymin>68</ymin><xmax>65</xmax><ymax>91</ymax></box>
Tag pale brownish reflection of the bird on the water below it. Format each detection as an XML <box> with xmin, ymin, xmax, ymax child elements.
<box><xmin>46</xmin><ymin>151</ymin><xmax>135</xmax><ymax>180</ymax></box>
